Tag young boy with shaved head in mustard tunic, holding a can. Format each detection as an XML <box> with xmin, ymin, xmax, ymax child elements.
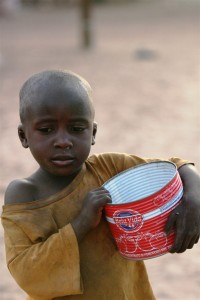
<box><xmin>2</xmin><ymin>71</ymin><xmax>200</xmax><ymax>300</ymax></box>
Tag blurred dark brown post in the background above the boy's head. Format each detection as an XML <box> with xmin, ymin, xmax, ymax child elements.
<box><xmin>80</xmin><ymin>0</ymin><xmax>92</xmax><ymax>48</ymax></box>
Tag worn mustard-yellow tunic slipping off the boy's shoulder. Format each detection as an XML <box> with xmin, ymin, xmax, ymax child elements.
<box><xmin>2</xmin><ymin>153</ymin><xmax>187</xmax><ymax>300</ymax></box>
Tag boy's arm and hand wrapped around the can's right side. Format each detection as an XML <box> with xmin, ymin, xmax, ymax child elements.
<box><xmin>165</xmin><ymin>164</ymin><xmax>200</xmax><ymax>253</ymax></box>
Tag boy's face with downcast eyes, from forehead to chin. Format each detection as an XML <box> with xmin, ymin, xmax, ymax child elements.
<box><xmin>19</xmin><ymin>87</ymin><xmax>96</xmax><ymax>176</ymax></box>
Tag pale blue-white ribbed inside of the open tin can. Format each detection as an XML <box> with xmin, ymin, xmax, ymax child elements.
<box><xmin>103</xmin><ymin>161</ymin><xmax>177</xmax><ymax>204</ymax></box>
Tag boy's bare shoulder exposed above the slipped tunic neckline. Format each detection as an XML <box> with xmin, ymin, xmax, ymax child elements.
<box><xmin>4</xmin><ymin>178</ymin><xmax>36</xmax><ymax>205</ymax></box>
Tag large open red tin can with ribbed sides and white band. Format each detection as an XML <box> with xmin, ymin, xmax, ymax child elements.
<box><xmin>103</xmin><ymin>161</ymin><xmax>183</xmax><ymax>260</ymax></box>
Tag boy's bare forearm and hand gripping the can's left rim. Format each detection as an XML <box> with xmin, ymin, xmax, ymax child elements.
<box><xmin>72</xmin><ymin>187</ymin><xmax>112</xmax><ymax>241</ymax></box>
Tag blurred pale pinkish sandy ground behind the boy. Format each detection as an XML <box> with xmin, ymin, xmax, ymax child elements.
<box><xmin>0</xmin><ymin>0</ymin><xmax>200</xmax><ymax>300</ymax></box>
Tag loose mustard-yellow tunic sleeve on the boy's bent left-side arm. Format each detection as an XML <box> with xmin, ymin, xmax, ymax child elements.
<box><xmin>2</xmin><ymin>214</ymin><xmax>83</xmax><ymax>300</ymax></box>
